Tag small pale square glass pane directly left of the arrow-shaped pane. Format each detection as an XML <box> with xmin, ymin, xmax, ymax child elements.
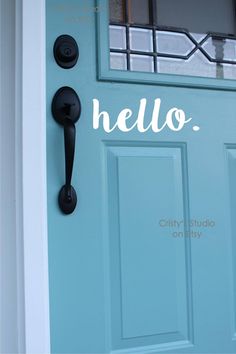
<box><xmin>130</xmin><ymin>28</ymin><xmax>153</xmax><ymax>52</ymax></box>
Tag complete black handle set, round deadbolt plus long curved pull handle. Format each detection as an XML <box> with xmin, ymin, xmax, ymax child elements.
<box><xmin>51</xmin><ymin>35</ymin><xmax>81</xmax><ymax>214</ymax></box>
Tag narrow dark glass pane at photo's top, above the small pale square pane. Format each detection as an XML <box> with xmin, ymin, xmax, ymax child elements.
<box><xmin>127</xmin><ymin>0</ymin><xmax>150</xmax><ymax>25</ymax></box>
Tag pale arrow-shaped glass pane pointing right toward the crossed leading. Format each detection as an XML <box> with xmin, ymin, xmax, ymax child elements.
<box><xmin>156</xmin><ymin>31</ymin><xmax>195</xmax><ymax>56</ymax></box>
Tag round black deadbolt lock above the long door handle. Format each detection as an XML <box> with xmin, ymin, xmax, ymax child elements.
<box><xmin>53</xmin><ymin>34</ymin><xmax>79</xmax><ymax>69</ymax></box>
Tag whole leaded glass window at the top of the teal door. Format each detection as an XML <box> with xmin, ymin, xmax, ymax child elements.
<box><xmin>109</xmin><ymin>0</ymin><xmax>236</xmax><ymax>79</ymax></box>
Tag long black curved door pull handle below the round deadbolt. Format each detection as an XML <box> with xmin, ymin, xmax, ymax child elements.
<box><xmin>51</xmin><ymin>86</ymin><xmax>81</xmax><ymax>214</ymax></box>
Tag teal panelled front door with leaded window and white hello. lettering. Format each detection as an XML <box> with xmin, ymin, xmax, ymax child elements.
<box><xmin>46</xmin><ymin>0</ymin><xmax>236</xmax><ymax>354</ymax></box>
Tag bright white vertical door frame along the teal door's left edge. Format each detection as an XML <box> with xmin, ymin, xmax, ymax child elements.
<box><xmin>19</xmin><ymin>0</ymin><xmax>50</xmax><ymax>353</ymax></box>
